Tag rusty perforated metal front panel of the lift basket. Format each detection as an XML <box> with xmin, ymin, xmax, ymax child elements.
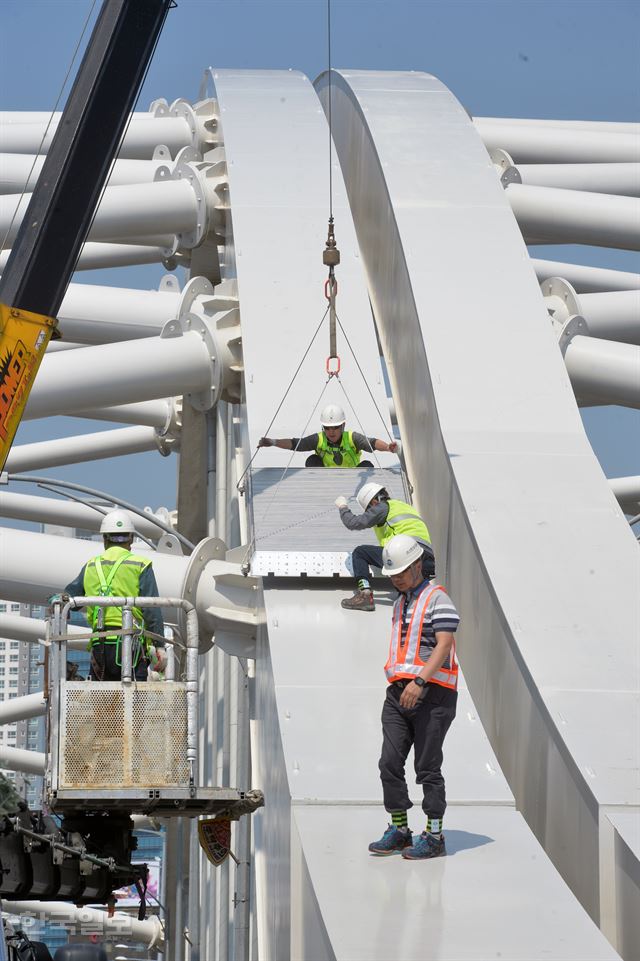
<box><xmin>59</xmin><ymin>681</ymin><xmax>189</xmax><ymax>791</ymax></box>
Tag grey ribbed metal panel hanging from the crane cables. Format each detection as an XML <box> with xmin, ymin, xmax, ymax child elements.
<box><xmin>251</xmin><ymin>467</ymin><xmax>408</xmax><ymax>577</ymax></box>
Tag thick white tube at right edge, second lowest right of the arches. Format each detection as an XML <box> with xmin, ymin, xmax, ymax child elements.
<box><xmin>564</xmin><ymin>335</ymin><xmax>640</xmax><ymax>408</ymax></box>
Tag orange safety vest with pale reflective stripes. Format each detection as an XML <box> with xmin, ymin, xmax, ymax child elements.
<box><xmin>384</xmin><ymin>584</ymin><xmax>458</xmax><ymax>691</ymax></box>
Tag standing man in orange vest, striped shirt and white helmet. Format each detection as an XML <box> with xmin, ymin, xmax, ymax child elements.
<box><xmin>369</xmin><ymin>534</ymin><xmax>460</xmax><ymax>860</ymax></box>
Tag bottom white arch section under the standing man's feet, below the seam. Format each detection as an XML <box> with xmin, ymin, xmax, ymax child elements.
<box><xmin>294</xmin><ymin>805</ymin><xmax>618</xmax><ymax>961</ymax></box>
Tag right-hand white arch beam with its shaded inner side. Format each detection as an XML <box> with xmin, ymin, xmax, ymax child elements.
<box><xmin>319</xmin><ymin>71</ymin><xmax>640</xmax><ymax>936</ymax></box>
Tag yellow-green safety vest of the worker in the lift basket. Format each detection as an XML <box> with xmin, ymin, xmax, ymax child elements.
<box><xmin>83</xmin><ymin>545</ymin><xmax>151</xmax><ymax>649</ymax></box>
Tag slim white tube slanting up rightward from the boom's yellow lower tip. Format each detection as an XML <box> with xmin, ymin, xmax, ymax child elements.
<box><xmin>5</xmin><ymin>427</ymin><xmax>159</xmax><ymax>472</ymax></box>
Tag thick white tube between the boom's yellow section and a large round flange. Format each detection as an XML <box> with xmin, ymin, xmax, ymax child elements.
<box><xmin>24</xmin><ymin>332</ymin><xmax>212</xmax><ymax>420</ymax></box>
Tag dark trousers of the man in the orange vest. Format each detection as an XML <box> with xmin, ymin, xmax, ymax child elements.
<box><xmin>378</xmin><ymin>684</ymin><xmax>458</xmax><ymax>818</ymax></box>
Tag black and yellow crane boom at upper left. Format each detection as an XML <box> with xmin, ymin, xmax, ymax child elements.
<box><xmin>0</xmin><ymin>0</ymin><xmax>173</xmax><ymax>470</ymax></box>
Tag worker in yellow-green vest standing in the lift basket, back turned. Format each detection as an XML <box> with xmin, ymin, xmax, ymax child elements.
<box><xmin>60</xmin><ymin>510</ymin><xmax>165</xmax><ymax>681</ymax></box>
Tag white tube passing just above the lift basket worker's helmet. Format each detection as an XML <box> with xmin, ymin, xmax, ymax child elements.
<box><xmin>0</xmin><ymin>492</ymin><xmax>164</xmax><ymax>536</ymax></box>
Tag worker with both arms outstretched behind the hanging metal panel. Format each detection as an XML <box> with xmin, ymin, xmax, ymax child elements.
<box><xmin>258</xmin><ymin>404</ymin><xmax>400</xmax><ymax>467</ymax></box>
